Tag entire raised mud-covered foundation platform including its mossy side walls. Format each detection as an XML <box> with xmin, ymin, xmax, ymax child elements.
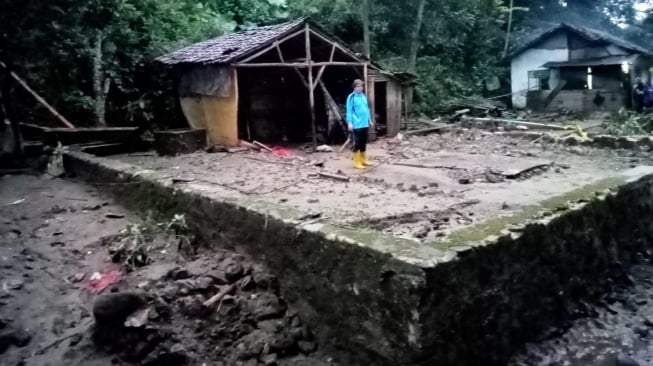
<box><xmin>66</xmin><ymin>131</ymin><xmax>653</xmax><ymax>365</ymax></box>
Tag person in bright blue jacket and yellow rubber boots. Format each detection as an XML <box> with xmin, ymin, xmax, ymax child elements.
<box><xmin>346</xmin><ymin>79</ymin><xmax>373</xmax><ymax>169</ymax></box>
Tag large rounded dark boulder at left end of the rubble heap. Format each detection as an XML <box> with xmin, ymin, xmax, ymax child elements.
<box><xmin>93</xmin><ymin>292</ymin><xmax>146</xmax><ymax>324</ymax></box>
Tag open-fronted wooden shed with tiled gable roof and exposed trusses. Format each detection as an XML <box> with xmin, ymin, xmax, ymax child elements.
<box><xmin>157</xmin><ymin>18</ymin><xmax>408</xmax><ymax>146</ymax></box>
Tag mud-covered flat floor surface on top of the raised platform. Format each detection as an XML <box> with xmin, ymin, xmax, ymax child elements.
<box><xmin>110</xmin><ymin>130</ymin><xmax>653</xmax><ymax>241</ymax></box>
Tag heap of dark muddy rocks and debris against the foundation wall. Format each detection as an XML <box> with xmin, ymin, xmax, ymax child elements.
<box><xmin>93</xmin><ymin>252</ymin><xmax>331</xmax><ymax>366</ymax></box>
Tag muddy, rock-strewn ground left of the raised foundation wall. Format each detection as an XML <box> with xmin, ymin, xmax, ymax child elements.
<box><xmin>0</xmin><ymin>175</ymin><xmax>336</xmax><ymax>366</ymax></box>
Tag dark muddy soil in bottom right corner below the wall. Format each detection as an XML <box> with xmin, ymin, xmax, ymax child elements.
<box><xmin>510</xmin><ymin>264</ymin><xmax>653</xmax><ymax>366</ymax></box>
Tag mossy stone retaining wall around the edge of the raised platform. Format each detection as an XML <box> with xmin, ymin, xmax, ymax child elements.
<box><xmin>66</xmin><ymin>153</ymin><xmax>653</xmax><ymax>366</ymax></box>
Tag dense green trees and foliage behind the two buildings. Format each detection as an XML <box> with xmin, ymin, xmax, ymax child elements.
<box><xmin>0</xmin><ymin>0</ymin><xmax>653</xmax><ymax>125</ymax></box>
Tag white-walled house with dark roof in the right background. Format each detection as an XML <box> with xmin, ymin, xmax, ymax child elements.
<box><xmin>511</xmin><ymin>23</ymin><xmax>653</xmax><ymax>112</ymax></box>
